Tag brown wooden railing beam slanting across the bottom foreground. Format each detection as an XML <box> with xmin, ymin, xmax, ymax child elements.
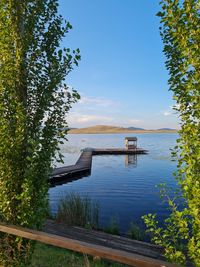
<box><xmin>0</xmin><ymin>223</ymin><xmax>178</xmax><ymax>267</ymax></box>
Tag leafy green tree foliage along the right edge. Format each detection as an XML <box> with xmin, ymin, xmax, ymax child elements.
<box><xmin>144</xmin><ymin>0</ymin><xmax>200</xmax><ymax>266</ymax></box>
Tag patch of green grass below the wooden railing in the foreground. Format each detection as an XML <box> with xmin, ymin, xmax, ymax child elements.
<box><xmin>29</xmin><ymin>243</ymin><xmax>126</xmax><ymax>267</ymax></box>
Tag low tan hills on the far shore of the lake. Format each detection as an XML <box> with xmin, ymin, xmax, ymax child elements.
<box><xmin>68</xmin><ymin>125</ymin><xmax>176</xmax><ymax>134</ymax></box>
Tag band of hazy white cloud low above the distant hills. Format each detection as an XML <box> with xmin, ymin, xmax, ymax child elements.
<box><xmin>67</xmin><ymin>94</ymin><xmax>180</xmax><ymax>129</ymax></box>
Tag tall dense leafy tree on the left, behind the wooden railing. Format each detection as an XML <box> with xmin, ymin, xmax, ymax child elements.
<box><xmin>0</xmin><ymin>0</ymin><xmax>80</xmax><ymax>266</ymax></box>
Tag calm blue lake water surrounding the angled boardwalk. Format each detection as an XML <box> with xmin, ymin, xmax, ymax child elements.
<box><xmin>49</xmin><ymin>133</ymin><xmax>178</xmax><ymax>233</ymax></box>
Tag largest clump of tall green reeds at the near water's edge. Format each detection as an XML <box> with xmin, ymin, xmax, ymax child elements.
<box><xmin>56</xmin><ymin>193</ymin><xmax>99</xmax><ymax>229</ymax></box>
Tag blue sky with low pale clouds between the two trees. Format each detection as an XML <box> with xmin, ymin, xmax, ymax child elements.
<box><xmin>59</xmin><ymin>0</ymin><xmax>178</xmax><ymax>129</ymax></box>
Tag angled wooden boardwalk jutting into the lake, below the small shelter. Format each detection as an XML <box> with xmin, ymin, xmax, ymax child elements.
<box><xmin>49</xmin><ymin>148</ymin><xmax>147</xmax><ymax>186</ymax></box>
